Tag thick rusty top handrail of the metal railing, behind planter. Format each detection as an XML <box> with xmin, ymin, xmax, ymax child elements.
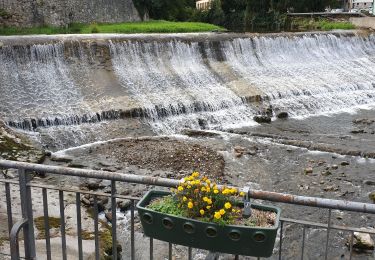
<box><xmin>0</xmin><ymin>160</ymin><xmax>375</xmax><ymax>214</ymax></box>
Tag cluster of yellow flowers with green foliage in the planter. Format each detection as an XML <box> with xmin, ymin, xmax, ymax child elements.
<box><xmin>173</xmin><ymin>172</ymin><xmax>244</xmax><ymax>223</ymax></box>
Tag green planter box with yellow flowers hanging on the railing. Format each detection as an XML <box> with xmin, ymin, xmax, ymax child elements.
<box><xmin>137</xmin><ymin>172</ymin><xmax>280</xmax><ymax>257</ymax></box>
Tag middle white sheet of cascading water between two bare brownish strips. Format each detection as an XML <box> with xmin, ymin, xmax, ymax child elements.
<box><xmin>110</xmin><ymin>41</ymin><xmax>254</xmax><ymax>133</ymax></box>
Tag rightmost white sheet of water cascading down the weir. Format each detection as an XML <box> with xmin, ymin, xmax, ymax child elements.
<box><xmin>222</xmin><ymin>35</ymin><xmax>375</xmax><ymax>116</ymax></box>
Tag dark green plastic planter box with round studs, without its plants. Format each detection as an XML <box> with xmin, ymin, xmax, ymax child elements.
<box><xmin>137</xmin><ymin>190</ymin><xmax>280</xmax><ymax>257</ymax></box>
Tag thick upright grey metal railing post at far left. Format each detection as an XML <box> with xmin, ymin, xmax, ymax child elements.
<box><xmin>18</xmin><ymin>169</ymin><xmax>36</xmax><ymax>260</ymax></box>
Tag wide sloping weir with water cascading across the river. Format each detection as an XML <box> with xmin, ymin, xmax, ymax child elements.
<box><xmin>0</xmin><ymin>33</ymin><xmax>375</xmax><ymax>144</ymax></box>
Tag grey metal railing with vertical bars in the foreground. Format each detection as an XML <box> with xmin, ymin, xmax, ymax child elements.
<box><xmin>0</xmin><ymin>160</ymin><xmax>375</xmax><ymax>260</ymax></box>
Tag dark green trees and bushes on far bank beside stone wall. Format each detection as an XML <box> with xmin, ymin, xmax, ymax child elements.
<box><xmin>133</xmin><ymin>0</ymin><xmax>356</xmax><ymax>31</ymax></box>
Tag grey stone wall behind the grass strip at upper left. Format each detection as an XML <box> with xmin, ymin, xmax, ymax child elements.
<box><xmin>0</xmin><ymin>0</ymin><xmax>140</xmax><ymax>27</ymax></box>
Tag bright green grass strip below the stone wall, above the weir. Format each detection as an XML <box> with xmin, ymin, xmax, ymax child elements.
<box><xmin>0</xmin><ymin>21</ymin><xmax>225</xmax><ymax>35</ymax></box>
